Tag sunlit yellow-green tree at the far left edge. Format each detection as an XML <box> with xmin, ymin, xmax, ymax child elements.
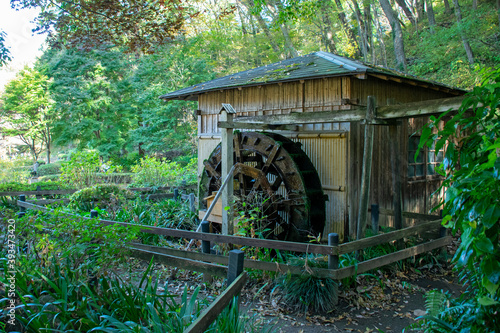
<box><xmin>0</xmin><ymin>67</ymin><xmax>52</xmax><ymax>163</ymax></box>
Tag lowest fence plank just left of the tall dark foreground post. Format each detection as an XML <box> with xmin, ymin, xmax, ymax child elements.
<box><xmin>130</xmin><ymin>248</ymin><xmax>227</xmax><ymax>277</ymax></box>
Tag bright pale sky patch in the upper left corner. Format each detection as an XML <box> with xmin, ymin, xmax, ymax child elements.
<box><xmin>0</xmin><ymin>0</ymin><xmax>45</xmax><ymax>91</ymax></box>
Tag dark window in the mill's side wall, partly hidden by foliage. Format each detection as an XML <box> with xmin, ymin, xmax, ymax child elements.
<box><xmin>408</xmin><ymin>136</ymin><xmax>444</xmax><ymax>178</ymax></box>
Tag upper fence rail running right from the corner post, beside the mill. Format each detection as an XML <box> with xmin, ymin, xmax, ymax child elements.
<box><xmin>338</xmin><ymin>220</ymin><xmax>441</xmax><ymax>254</ymax></box>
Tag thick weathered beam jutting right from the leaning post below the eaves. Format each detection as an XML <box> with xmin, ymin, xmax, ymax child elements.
<box><xmin>376</xmin><ymin>96</ymin><xmax>464</xmax><ymax>119</ymax></box>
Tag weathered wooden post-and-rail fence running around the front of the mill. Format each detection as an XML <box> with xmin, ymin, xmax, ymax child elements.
<box><xmin>17</xmin><ymin>195</ymin><xmax>451</xmax><ymax>326</ymax></box>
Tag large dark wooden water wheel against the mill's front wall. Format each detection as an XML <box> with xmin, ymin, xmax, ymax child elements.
<box><xmin>200</xmin><ymin>132</ymin><xmax>325</xmax><ymax>241</ymax></box>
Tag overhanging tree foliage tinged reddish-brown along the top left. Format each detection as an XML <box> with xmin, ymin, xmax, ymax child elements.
<box><xmin>11</xmin><ymin>0</ymin><xmax>194</xmax><ymax>53</ymax></box>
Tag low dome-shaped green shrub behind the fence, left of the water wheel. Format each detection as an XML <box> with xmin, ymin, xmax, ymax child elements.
<box><xmin>69</xmin><ymin>184</ymin><xmax>134</xmax><ymax>211</ymax></box>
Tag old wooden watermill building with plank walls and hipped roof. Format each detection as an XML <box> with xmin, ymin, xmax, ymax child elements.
<box><xmin>161</xmin><ymin>52</ymin><xmax>465</xmax><ymax>238</ymax></box>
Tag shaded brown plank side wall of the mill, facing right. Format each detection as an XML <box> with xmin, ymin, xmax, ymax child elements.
<box><xmin>348</xmin><ymin>77</ymin><xmax>453</xmax><ymax>236</ymax></box>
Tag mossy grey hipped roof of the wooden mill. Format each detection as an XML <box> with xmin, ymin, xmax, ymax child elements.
<box><xmin>160</xmin><ymin>51</ymin><xmax>464</xmax><ymax>100</ymax></box>
